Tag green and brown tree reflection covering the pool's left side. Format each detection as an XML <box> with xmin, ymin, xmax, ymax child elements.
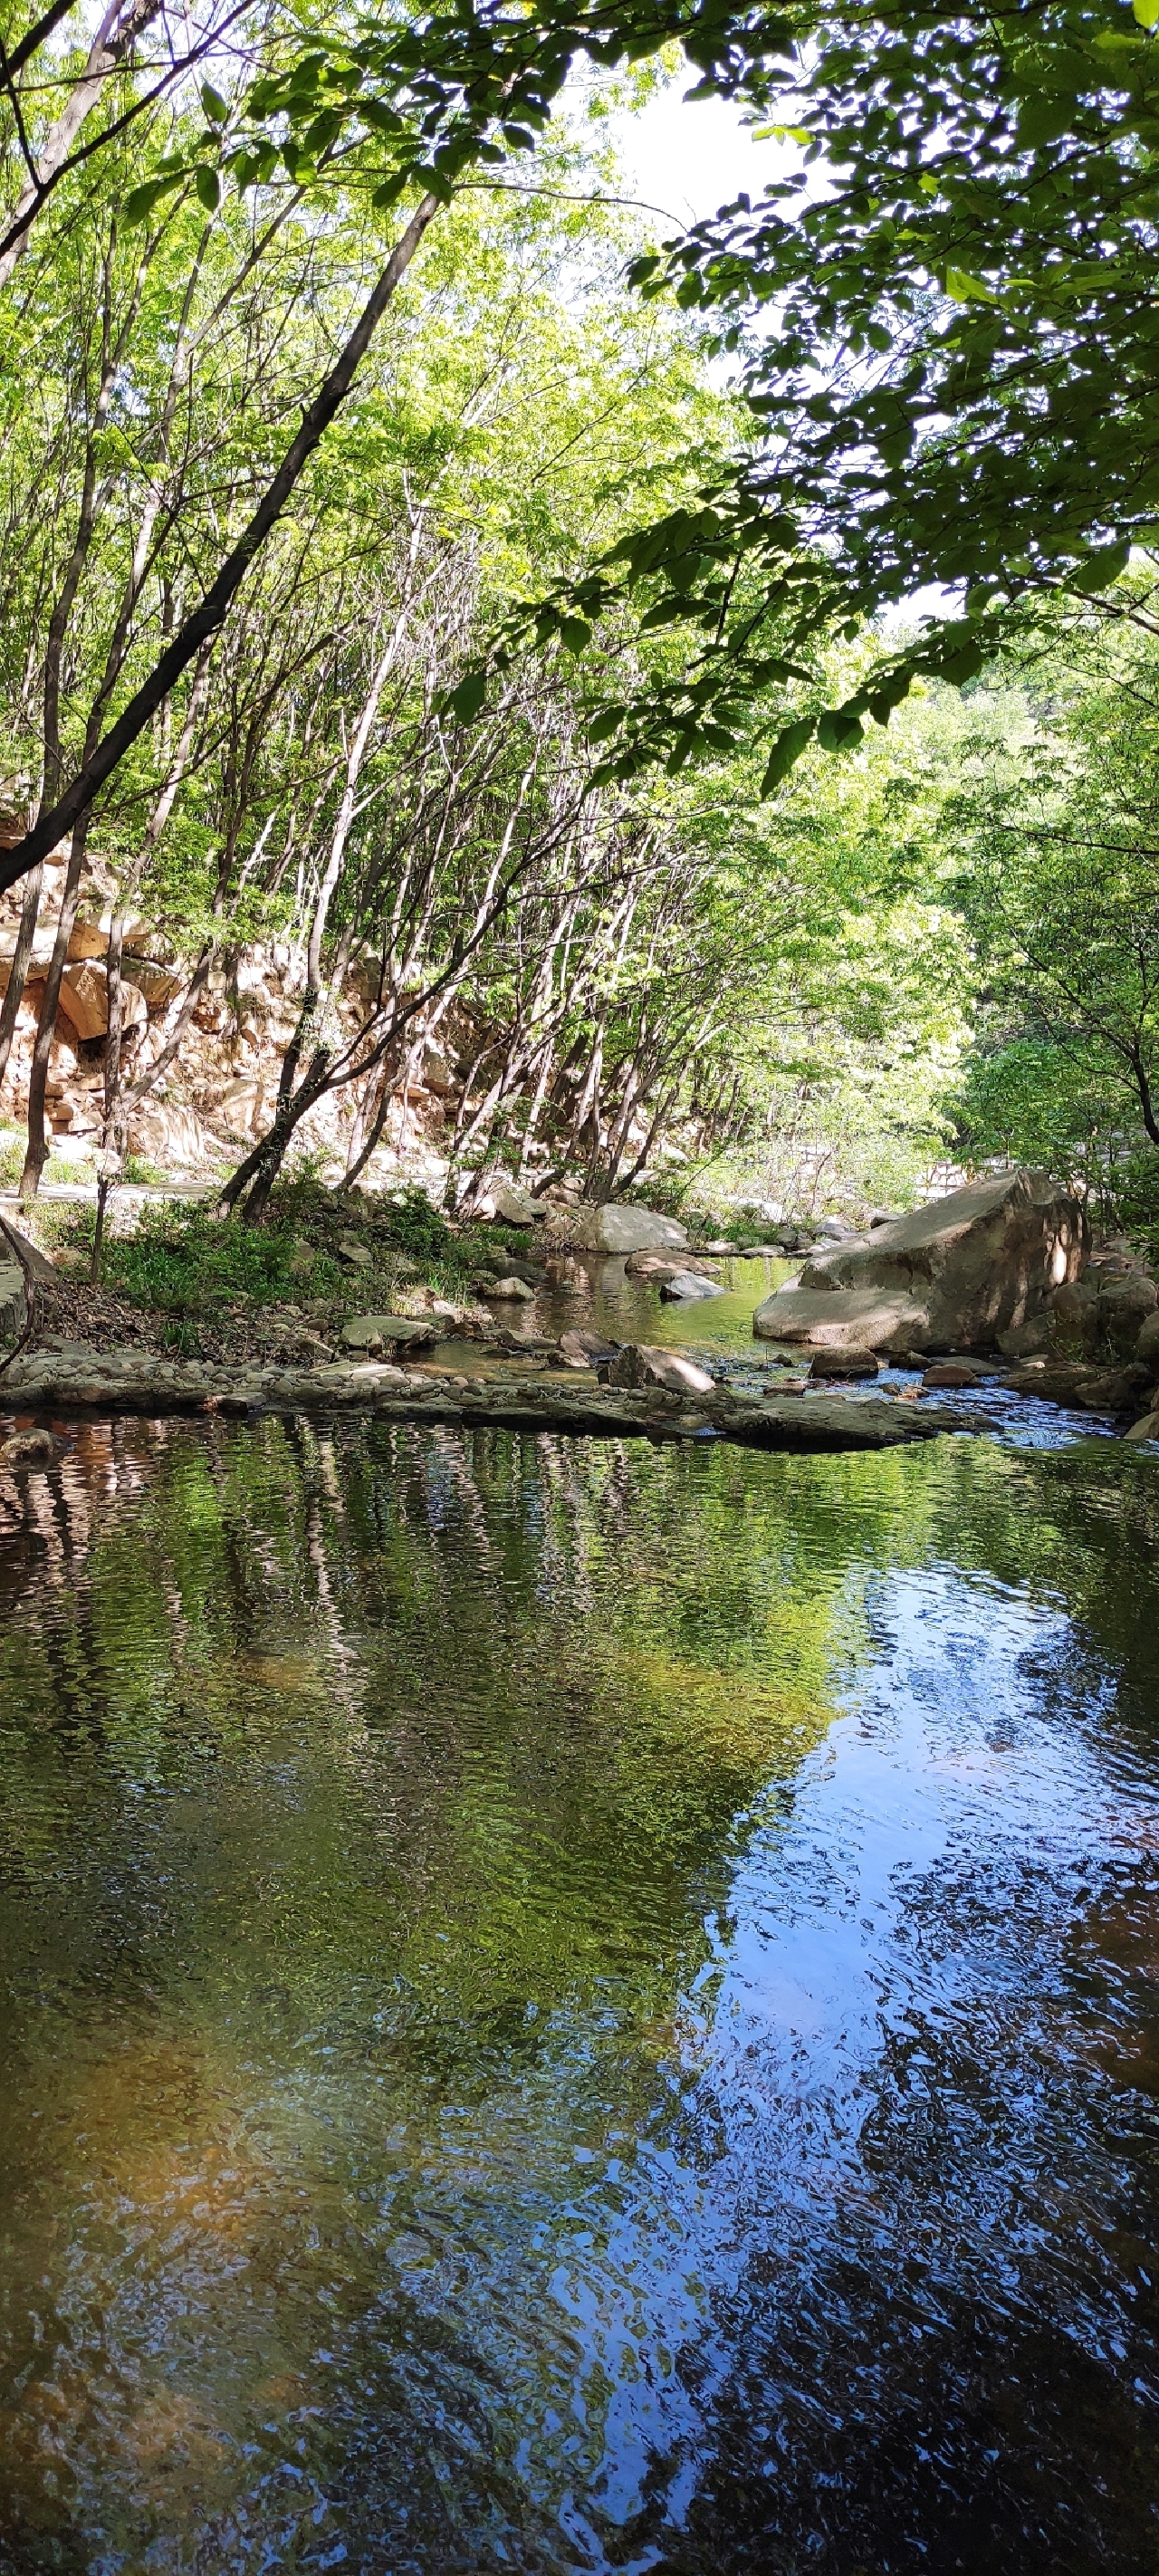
<box><xmin>0</xmin><ymin>1422</ymin><xmax>1149</xmax><ymax>2568</ymax></box>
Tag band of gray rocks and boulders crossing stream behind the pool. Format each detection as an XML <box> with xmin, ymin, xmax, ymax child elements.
<box><xmin>0</xmin><ymin>1172</ymin><xmax>1159</xmax><ymax>1463</ymax></box>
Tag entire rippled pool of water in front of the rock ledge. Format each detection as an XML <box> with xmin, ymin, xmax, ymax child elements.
<box><xmin>0</xmin><ymin>1422</ymin><xmax>1159</xmax><ymax>2576</ymax></box>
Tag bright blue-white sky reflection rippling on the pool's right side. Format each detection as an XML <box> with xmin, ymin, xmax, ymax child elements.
<box><xmin>510</xmin><ymin>1571</ymin><xmax>1154</xmax><ymax>2568</ymax></box>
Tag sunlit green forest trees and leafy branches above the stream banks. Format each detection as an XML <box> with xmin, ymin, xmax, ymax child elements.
<box><xmin>0</xmin><ymin>0</ymin><xmax>1159</xmax><ymax>1219</ymax></box>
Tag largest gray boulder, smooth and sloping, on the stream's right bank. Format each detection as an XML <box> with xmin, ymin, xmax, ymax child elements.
<box><xmin>752</xmin><ymin>1172</ymin><xmax>1089</xmax><ymax>1350</ymax></box>
